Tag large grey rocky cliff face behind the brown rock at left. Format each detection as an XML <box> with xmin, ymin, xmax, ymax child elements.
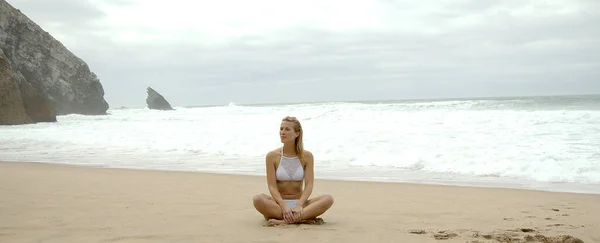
<box><xmin>0</xmin><ymin>0</ymin><xmax>108</xmax><ymax>115</ymax></box>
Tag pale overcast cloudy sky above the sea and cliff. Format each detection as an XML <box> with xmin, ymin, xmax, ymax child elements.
<box><xmin>8</xmin><ymin>0</ymin><xmax>600</xmax><ymax>107</ymax></box>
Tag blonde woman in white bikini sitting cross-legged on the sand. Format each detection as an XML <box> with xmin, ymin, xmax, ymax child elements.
<box><xmin>253</xmin><ymin>116</ymin><xmax>333</xmax><ymax>224</ymax></box>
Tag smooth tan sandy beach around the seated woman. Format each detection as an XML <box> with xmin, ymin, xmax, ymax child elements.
<box><xmin>0</xmin><ymin>162</ymin><xmax>600</xmax><ymax>243</ymax></box>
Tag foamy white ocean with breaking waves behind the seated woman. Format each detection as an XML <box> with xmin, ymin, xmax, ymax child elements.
<box><xmin>0</xmin><ymin>95</ymin><xmax>600</xmax><ymax>193</ymax></box>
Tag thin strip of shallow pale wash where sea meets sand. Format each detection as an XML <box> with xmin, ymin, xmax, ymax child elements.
<box><xmin>0</xmin><ymin>160</ymin><xmax>600</xmax><ymax>195</ymax></box>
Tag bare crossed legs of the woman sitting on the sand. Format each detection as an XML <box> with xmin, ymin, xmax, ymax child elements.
<box><xmin>253</xmin><ymin>193</ymin><xmax>333</xmax><ymax>223</ymax></box>
